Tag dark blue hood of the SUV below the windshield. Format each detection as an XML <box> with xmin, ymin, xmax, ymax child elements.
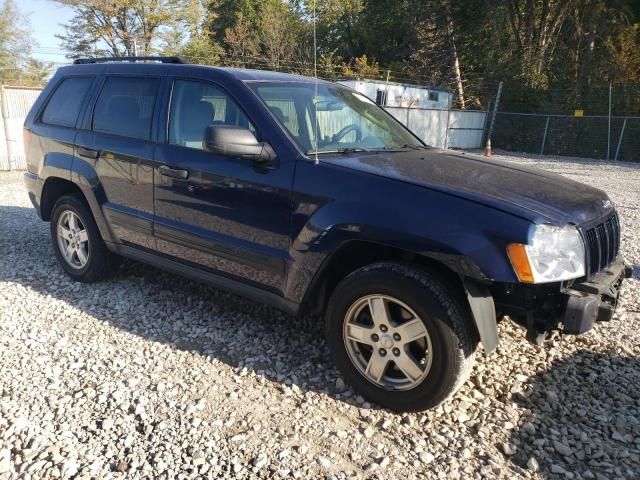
<box><xmin>323</xmin><ymin>149</ymin><xmax>612</xmax><ymax>225</ymax></box>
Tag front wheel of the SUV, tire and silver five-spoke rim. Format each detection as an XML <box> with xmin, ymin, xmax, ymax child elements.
<box><xmin>325</xmin><ymin>262</ymin><xmax>477</xmax><ymax>411</ymax></box>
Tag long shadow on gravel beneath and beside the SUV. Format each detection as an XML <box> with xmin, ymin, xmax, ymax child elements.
<box><xmin>0</xmin><ymin>206</ymin><xmax>372</xmax><ymax>409</ymax></box>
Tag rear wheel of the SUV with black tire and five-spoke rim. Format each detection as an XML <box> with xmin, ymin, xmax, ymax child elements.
<box><xmin>51</xmin><ymin>195</ymin><xmax>118</xmax><ymax>283</ymax></box>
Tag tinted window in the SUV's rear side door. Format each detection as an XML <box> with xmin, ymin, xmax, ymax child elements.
<box><xmin>93</xmin><ymin>77</ymin><xmax>159</xmax><ymax>140</ymax></box>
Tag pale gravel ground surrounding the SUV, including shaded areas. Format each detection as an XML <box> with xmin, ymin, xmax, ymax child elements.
<box><xmin>0</xmin><ymin>156</ymin><xmax>640</xmax><ymax>480</ymax></box>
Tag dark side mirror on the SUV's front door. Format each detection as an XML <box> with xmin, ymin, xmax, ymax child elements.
<box><xmin>202</xmin><ymin>125</ymin><xmax>276</xmax><ymax>163</ymax></box>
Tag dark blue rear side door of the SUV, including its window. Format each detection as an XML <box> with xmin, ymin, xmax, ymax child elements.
<box><xmin>76</xmin><ymin>74</ymin><xmax>161</xmax><ymax>249</ymax></box>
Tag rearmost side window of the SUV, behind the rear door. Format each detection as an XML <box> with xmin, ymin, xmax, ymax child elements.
<box><xmin>42</xmin><ymin>77</ymin><xmax>93</xmax><ymax>127</ymax></box>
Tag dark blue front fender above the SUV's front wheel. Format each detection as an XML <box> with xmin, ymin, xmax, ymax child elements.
<box><xmin>285</xmin><ymin>164</ymin><xmax>530</xmax><ymax>301</ymax></box>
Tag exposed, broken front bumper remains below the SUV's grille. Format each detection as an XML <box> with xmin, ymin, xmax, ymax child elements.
<box><xmin>562</xmin><ymin>257</ymin><xmax>631</xmax><ymax>334</ymax></box>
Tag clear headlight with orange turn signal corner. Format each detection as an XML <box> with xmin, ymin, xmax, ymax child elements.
<box><xmin>507</xmin><ymin>224</ymin><xmax>585</xmax><ymax>283</ymax></box>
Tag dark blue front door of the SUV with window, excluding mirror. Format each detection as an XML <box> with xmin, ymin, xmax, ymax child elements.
<box><xmin>154</xmin><ymin>78</ymin><xmax>293</xmax><ymax>291</ymax></box>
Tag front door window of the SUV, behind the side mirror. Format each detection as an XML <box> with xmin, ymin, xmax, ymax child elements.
<box><xmin>169</xmin><ymin>80</ymin><xmax>256</xmax><ymax>150</ymax></box>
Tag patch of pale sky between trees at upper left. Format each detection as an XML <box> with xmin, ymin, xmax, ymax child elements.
<box><xmin>20</xmin><ymin>0</ymin><xmax>73</xmax><ymax>63</ymax></box>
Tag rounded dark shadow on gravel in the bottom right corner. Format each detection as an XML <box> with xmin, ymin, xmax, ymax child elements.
<box><xmin>510</xmin><ymin>351</ymin><xmax>640</xmax><ymax>480</ymax></box>
